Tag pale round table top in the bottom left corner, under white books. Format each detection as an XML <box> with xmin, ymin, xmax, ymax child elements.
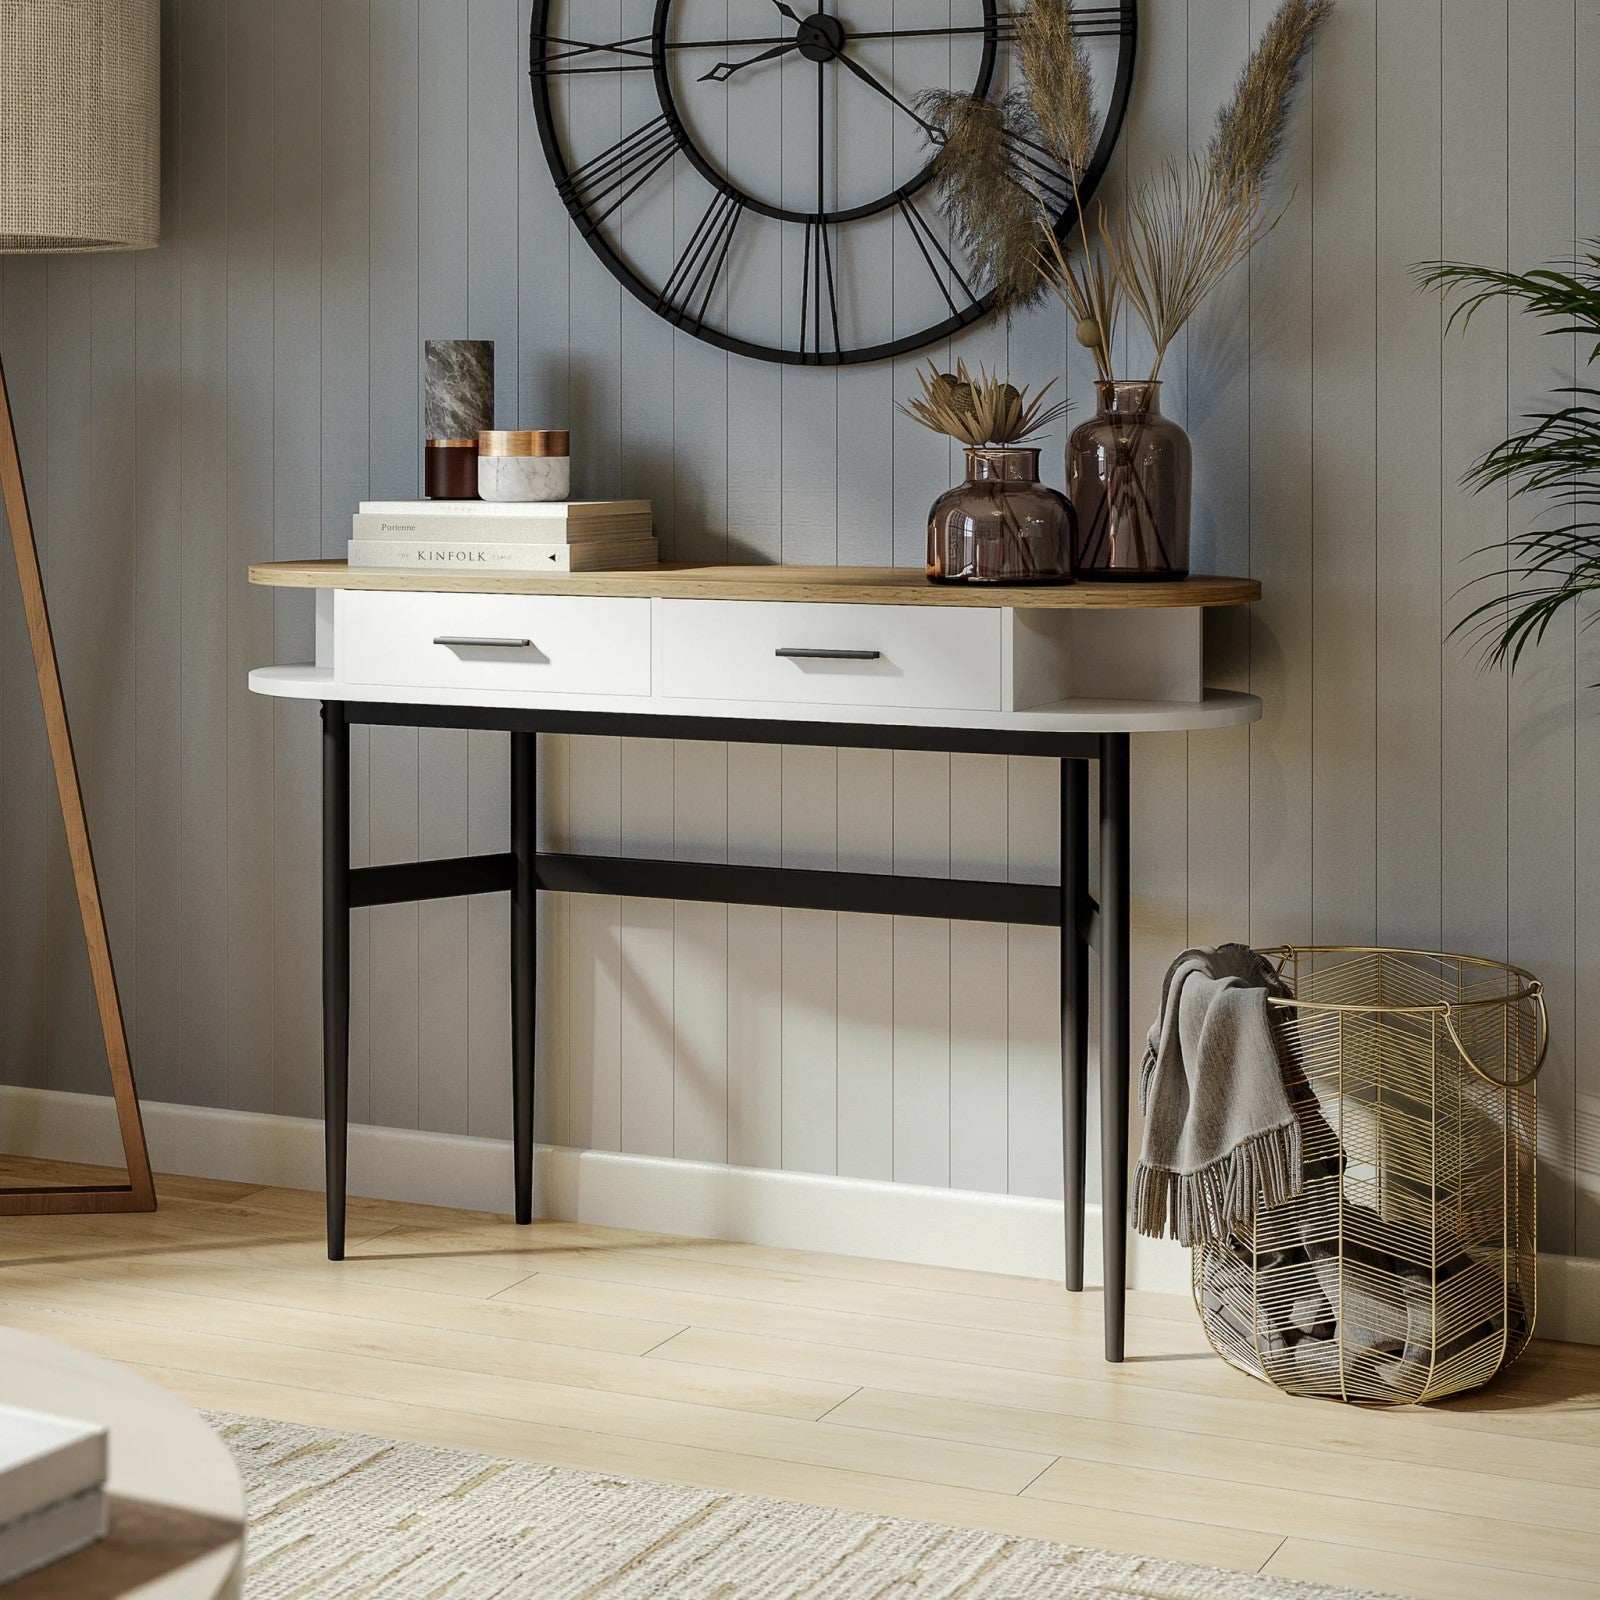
<box><xmin>0</xmin><ymin>1328</ymin><xmax>245</xmax><ymax>1600</ymax></box>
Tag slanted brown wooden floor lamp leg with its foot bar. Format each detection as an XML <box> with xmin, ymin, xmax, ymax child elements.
<box><xmin>0</xmin><ymin>356</ymin><xmax>155</xmax><ymax>1216</ymax></box>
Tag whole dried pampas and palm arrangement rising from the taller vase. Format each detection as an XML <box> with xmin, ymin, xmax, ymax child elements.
<box><xmin>920</xmin><ymin>0</ymin><xmax>1333</xmax><ymax>381</ymax></box>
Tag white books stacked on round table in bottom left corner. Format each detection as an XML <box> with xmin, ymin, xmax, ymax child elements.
<box><xmin>0</xmin><ymin>1406</ymin><xmax>106</xmax><ymax>1584</ymax></box>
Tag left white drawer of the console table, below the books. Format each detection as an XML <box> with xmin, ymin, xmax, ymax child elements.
<box><xmin>334</xmin><ymin>590</ymin><xmax>650</xmax><ymax>694</ymax></box>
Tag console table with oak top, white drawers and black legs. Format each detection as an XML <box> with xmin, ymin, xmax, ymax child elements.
<box><xmin>250</xmin><ymin>562</ymin><xmax>1261</xmax><ymax>1362</ymax></box>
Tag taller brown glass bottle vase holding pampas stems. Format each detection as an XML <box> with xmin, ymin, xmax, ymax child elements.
<box><xmin>1067</xmin><ymin>381</ymin><xmax>1194</xmax><ymax>581</ymax></box>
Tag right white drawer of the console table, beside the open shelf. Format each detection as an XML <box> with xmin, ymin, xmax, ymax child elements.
<box><xmin>661</xmin><ymin>600</ymin><xmax>1002</xmax><ymax>710</ymax></box>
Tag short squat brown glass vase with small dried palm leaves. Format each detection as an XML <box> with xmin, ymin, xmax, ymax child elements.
<box><xmin>928</xmin><ymin>445</ymin><xmax>1072</xmax><ymax>584</ymax></box>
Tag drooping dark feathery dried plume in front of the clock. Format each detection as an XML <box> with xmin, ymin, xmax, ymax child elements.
<box><xmin>917</xmin><ymin>90</ymin><xmax>1045</xmax><ymax>312</ymax></box>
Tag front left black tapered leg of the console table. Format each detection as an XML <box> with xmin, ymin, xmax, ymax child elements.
<box><xmin>322</xmin><ymin>701</ymin><xmax>350</xmax><ymax>1261</ymax></box>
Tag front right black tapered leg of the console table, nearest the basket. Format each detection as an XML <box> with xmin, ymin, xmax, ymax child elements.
<box><xmin>1099</xmin><ymin>733</ymin><xmax>1130</xmax><ymax>1362</ymax></box>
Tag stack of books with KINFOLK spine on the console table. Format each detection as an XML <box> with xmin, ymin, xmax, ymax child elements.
<box><xmin>350</xmin><ymin>501</ymin><xmax>661</xmax><ymax>573</ymax></box>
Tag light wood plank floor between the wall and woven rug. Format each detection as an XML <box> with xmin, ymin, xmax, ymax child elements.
<box><xmin>0</xmin><ymin>1160</ymin><xmax>1600</xmax><ymax>1600</ymax></box>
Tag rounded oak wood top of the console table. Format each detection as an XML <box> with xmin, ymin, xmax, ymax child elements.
<box><xmin>250</xmin><ymin>562</ymin><xmax>1261</xmax><ymax>611</ymax></box>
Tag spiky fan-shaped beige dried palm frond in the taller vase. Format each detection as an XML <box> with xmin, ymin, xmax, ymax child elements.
<box><xmin>1102</xmin><ymin>157</ymin><xmax>1277</xmax><ymax>382</ymax></box>
